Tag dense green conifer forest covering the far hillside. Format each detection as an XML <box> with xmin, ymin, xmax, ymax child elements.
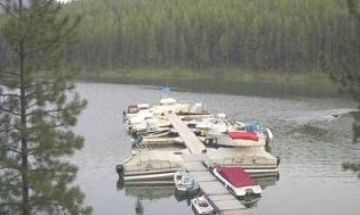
<box><xmin>2</xmin><ymin>0</ymin><xmax>360</xmax><ymax>72</ymax></box>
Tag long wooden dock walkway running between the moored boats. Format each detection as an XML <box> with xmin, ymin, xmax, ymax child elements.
<box><xmin>167</xmin><ymin>114</ymin><xmax>251</xmax><ymax>215</ymax></box>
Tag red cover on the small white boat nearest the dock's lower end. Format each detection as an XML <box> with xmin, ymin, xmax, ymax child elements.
<box><xmin>216</xmin><ymin>167</ymin><xmax>256</xmax><ymax>187</ymax></box>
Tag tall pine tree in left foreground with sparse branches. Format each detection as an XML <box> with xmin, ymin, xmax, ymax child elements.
<box><xmin>0</xmin><ymin>0</ymin><xmax>91</xmax><ymax>215</ymax></box>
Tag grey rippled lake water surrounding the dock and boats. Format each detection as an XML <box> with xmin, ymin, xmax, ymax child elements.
<box><xmin>72</xmin><ymin>83</ymin><xmax>360</xmax><ymax>215</ymax></box>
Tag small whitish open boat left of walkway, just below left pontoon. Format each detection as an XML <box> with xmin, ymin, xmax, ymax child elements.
<box><xmin>174</xmin><ymin>170</ymin><xmax>200</xmax><ymax>193</ymax></box>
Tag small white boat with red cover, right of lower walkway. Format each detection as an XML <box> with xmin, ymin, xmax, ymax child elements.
<box><xmin>213</xmin><ymin>167</ymin><xmax>262</xmax><ymax>198</ymax></box>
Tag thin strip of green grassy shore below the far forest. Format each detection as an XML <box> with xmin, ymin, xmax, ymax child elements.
<box><xmin>81</xmin><ymin>68</ymin><xmax>334</xmax><ymax>87</ymax></box>
